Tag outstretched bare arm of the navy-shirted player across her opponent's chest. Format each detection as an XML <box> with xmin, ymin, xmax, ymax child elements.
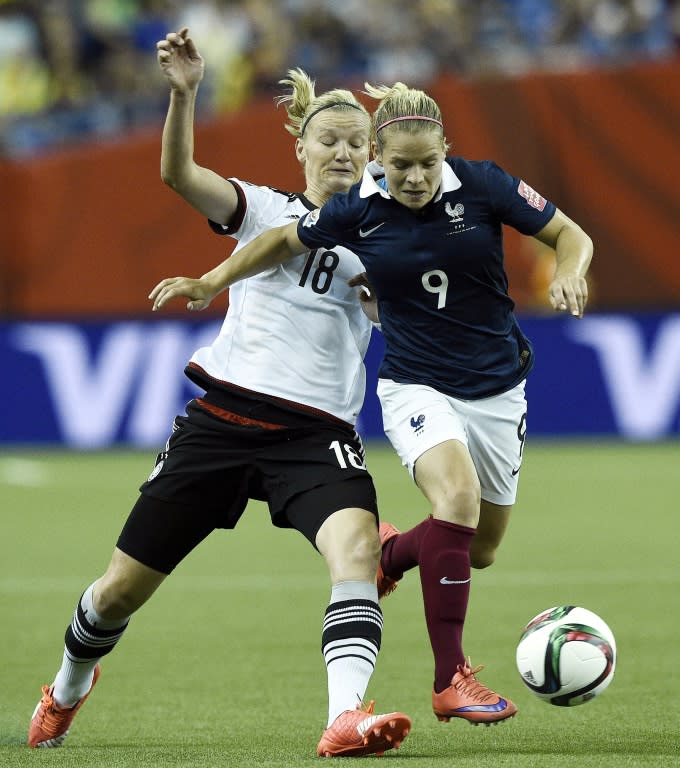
<box><xmin>149</xmin><ymin>221</ymin><xmax>307</xmax><ymax>312</ymax></box>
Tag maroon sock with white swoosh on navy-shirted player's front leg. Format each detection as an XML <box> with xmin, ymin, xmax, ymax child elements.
<box><xmin>419</xmin><ymin>519</ymin><xmax>475</xmax><ymax>693</ymax></box>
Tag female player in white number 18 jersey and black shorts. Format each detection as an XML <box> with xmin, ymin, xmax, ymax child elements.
<box><xmin>29</xmin><ymin>29</ymin><xmax>410</xmax><ymax>756</ymax></box>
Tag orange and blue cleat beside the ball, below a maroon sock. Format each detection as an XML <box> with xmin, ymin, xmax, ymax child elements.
<box><xmin>432</xmin><ymin>659</ymin><xmax>517</xmax><ymax>725</ymax></box>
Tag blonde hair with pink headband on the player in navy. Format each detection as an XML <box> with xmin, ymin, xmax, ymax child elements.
<box><xmin>364</xmin><ymin>83</ymin><xmax>449</xmax><ymax>152</ymax></box>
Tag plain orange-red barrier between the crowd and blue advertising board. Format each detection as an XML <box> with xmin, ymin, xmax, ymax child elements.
<box><xmin>0</xmin><ymin>56</ymin><xmax>680</xmax><ymax>317</ymax></box>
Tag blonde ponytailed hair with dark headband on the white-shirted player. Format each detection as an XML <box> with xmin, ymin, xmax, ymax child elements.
<box><xmin>276</xmin><ymin>67</ymin><xmax>371</xmax><ymax>139</ymax></box>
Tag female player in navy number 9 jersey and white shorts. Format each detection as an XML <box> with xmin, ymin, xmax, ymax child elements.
<box><xmin>154</xmin><ymin>83</ymin><xmax>592</xmax><ymax>723</ymax></box>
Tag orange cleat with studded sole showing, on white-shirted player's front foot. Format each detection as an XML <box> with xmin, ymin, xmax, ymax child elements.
<box><xmin>316</xmin><ymin>701</ymin><xmax>411</xmax><ymax>757</ymax></box>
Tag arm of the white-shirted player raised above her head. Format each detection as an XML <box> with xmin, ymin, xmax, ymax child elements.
<box><xmin>156</xmin><ymin>27</ymin><xmax>238</xmax><ymax>224</ymax></box>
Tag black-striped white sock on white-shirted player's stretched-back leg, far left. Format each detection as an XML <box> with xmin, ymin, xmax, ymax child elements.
<box><xmin>53</xmin><ymin>584</ymin><xmax>130</xmax><ymax>707</ymax></box>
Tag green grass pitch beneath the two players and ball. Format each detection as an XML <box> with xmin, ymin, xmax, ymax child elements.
<box><xmin>0</xmin><ymin>442</ymin><xmax>680</xmax><ymax>768</ymax></box>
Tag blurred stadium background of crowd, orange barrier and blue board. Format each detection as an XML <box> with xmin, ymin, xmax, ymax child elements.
<box><xmin>0</xmin><ymin>0</ymin><xmax>680</xmax><ymax>448</ymax></box>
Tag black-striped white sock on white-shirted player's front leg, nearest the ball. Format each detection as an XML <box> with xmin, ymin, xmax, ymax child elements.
<box><xmin>321</xmin><ymin>581</ymin><xmax>383</xmax><ymax>727</ymax></box>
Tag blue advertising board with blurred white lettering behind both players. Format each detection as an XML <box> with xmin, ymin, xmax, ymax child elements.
<box><xmin>0</xmin><ymin>314</ymin><xmax>680</xmax><ymax>448</ymax></box>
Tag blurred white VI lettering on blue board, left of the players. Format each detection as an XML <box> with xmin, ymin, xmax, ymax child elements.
<box><xmin>12</xmin><ymin>322</ymin><xmax>221</xmax><ymax>448</ymax></box>
